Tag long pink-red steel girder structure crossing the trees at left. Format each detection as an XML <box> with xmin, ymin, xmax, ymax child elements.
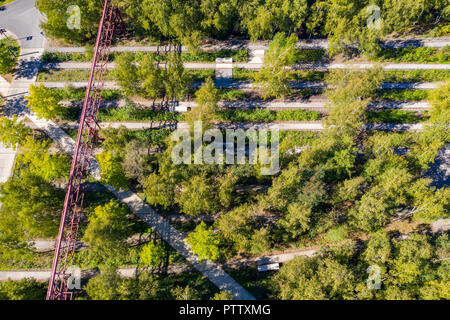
<box><xmin>47</xmin><ymin>0</ymin><xmax>117</xmax><ymax>300</ymax></box>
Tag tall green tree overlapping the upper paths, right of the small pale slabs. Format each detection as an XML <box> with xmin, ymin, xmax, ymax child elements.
<box><xmin>254</xmin><ymin>33</ymin><xmax>297</xmax><ymax>99</ymax></box>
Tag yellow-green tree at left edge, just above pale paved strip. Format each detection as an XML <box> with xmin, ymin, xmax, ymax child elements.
<box><xmin>0</xmin><ymin>116</ymin><xmax>31</xmax><ymax>150</ymax></box>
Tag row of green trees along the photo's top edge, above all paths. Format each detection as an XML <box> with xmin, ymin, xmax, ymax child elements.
<box><xmin>37</xmin><ymin>0</ymin><xmax>450</xmax><ymax>54</ymax></box>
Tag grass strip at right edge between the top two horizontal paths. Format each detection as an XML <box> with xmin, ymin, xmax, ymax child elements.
<box><xmin>377</xmin><ymin>46</ymin><xmax>450</xmax><ymax>63</ymax></box>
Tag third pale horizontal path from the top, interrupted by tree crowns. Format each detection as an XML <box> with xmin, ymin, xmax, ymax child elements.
<box><xmin>37</xmin><ymin>81</ymin><xmax>442</xmax><ymax>90</ymax></box>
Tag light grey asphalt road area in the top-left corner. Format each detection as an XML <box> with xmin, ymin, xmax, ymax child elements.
<box><xmin>0</xmin><ymin>0</ymin><xmax>44</xmax><ymax>49</ymax></box>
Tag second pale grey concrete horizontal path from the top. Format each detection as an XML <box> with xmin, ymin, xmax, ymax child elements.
<box><xmin>42</xmin><ymin>61</ymin><xmax>450</xmax><ymax>71</ymax></box>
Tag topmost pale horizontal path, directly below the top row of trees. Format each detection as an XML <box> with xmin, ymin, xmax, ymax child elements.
<box><xmin>48</xmin><ymin>37</ymin><xmax>450</xmax><ymax>53</ymax></box>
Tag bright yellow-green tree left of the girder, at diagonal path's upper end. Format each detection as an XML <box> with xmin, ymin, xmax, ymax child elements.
<box><xmin>25</xmin><ymin>83</ymin><xmax>65</xmax><ymax>120</ymax></box>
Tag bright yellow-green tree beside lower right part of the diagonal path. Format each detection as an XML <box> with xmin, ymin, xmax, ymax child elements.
<box><xmin>186</xmin><ymin>222</ymin><xmax>220</xmax><ymax>261</ymax></box>
